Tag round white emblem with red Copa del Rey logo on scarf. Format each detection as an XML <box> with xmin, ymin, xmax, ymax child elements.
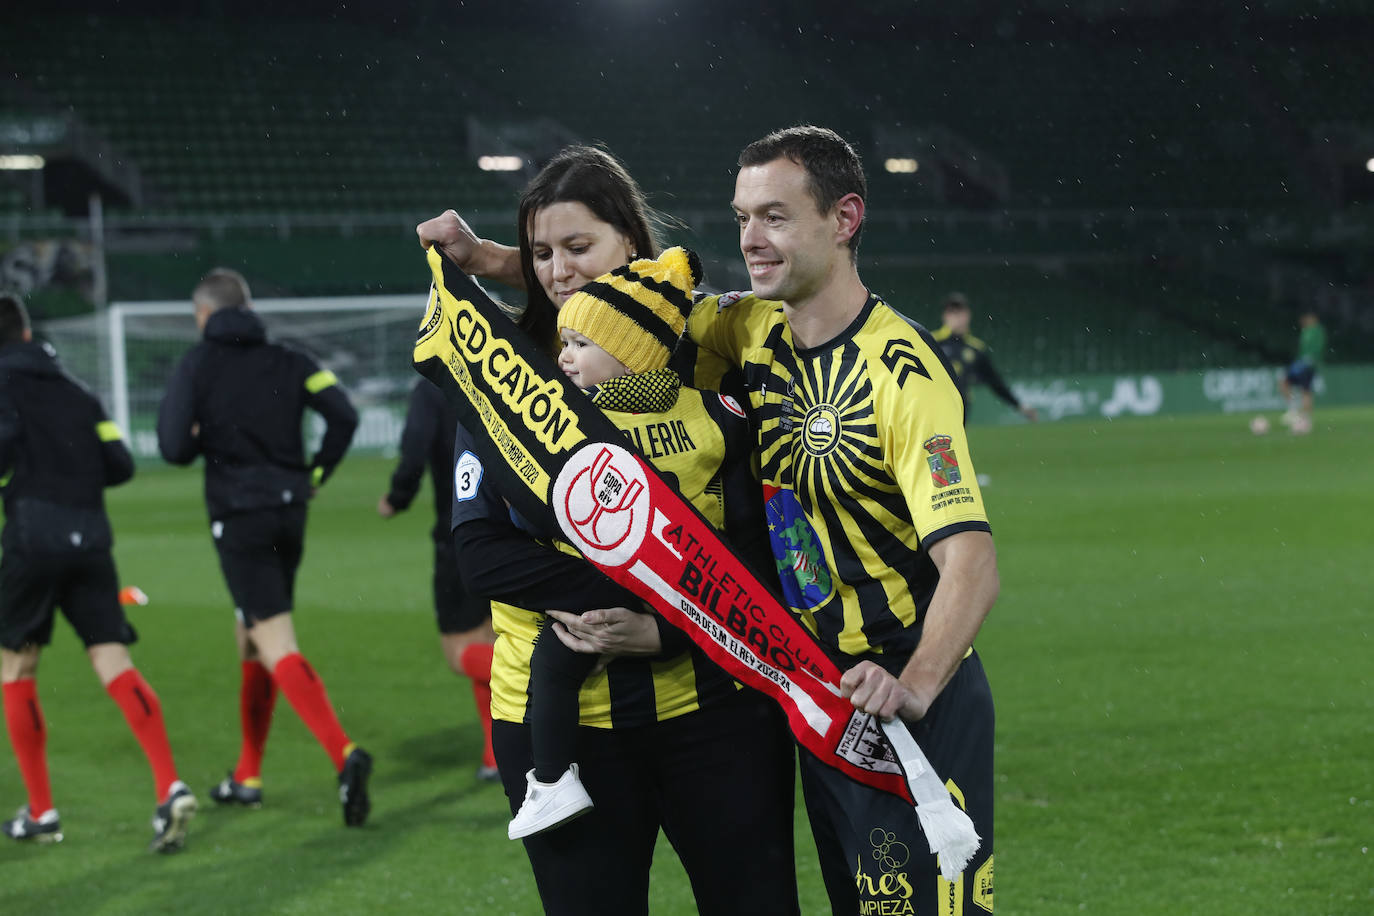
<box><xmin>554</xmin><ymin>444</ymin><xmax>650</xmax><ymax>566</ymax></box>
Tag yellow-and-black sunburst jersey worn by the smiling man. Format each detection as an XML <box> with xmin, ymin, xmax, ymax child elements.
<box><xmin>687</xmin><ymin>293</ymin><xmax>991</xmax><ymax>655</ymax></box>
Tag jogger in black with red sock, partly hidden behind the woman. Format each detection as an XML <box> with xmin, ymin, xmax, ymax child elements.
<box><xmin>376</xmin><ymin>379</ymin><xmax>500</xmax><ymax>781</ymax></box>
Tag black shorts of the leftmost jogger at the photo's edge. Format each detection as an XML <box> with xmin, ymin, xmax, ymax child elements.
<box><xmin>0</xmin><ymin>548</ymin><xmax>139</xmax><ymax>652</ymax></box>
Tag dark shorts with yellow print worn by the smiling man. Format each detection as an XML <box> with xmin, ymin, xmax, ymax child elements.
<box><xmin>798</xmin><ymin>654</ymin><xmax>993</xmax><ymax>916</ymax></box>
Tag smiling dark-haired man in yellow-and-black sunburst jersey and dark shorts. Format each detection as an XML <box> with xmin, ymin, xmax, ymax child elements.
<box><xmin>688</xmin><ymin>126</ymin><xmax>999</xmax><ymax>916</ymax></box>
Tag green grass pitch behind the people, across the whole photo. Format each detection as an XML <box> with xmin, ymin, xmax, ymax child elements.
<box><xmin>0</xmin><ymin>408</ymin><xmax>1374</xmax><ymax>916</ymax></box>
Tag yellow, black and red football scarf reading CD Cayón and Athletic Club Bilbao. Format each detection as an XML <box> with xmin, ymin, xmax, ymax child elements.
<box><xmin>415</xmin><ymin>249</ymin><xmax>967</xmax><ymax>823</ymax></box>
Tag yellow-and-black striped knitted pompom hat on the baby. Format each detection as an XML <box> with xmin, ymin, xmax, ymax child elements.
<box><xmin>558</xmin><ymin>247</ymin><xmax>702</xmax><ymax>372</ymax></box>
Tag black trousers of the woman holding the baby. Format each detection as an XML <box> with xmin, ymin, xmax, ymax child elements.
<box><xmin>492</xmin><ymin>689</ymin><xmax>800</xmax><ymax>916</ymax></box>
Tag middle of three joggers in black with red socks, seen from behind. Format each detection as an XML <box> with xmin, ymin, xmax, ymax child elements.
<box><xmin>158</xmin><ymin>269</ymin><xmax>372</xmax><ymax>827</ymax></box>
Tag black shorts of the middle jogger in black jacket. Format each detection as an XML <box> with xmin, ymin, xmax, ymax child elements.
<box><xmin>210</xmin><ymin>505</ymin><xmax>305</xmax><ymax>626</ymax></box>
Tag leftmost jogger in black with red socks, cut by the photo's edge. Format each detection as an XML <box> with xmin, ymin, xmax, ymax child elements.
<box><xmin>0</xmin><ymin>295</ymin><xmax>196</xmax><ymax>853</ymax></box>
